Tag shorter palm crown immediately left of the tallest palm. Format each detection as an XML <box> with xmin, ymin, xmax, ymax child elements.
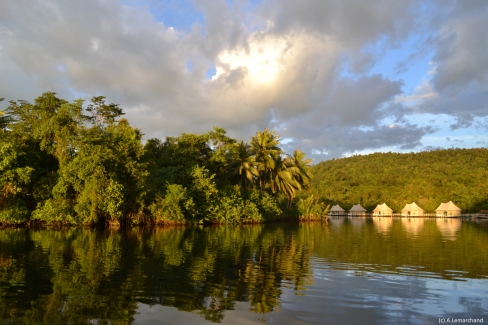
<box><xmin>229</xmin><ymin>141</ymin><xmax>259</xmax><ymax>187</ymax></box>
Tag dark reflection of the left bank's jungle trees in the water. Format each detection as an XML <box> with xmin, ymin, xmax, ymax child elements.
<box><xmin>0</xmin><ymin>225</ymin><xmax>313</xmax><ymax>324</ymax></box>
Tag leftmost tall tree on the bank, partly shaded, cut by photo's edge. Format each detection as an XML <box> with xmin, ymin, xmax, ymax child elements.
<box><xmin>0</xmin><ymin>92</ymin><xmax>73</xmax><ymax>221</ymax></box>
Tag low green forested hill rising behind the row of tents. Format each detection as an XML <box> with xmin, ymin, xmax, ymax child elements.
<box><xmin>312</xmin><ymin>148</ymin><xmax>488</xmax><ymax>212</ymax></box>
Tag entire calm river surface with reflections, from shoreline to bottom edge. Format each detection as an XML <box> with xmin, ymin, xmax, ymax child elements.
<box><xmin>0</xmin><ymin>217</ymin><xmax>488</xmax><ymax>324</ymax></box>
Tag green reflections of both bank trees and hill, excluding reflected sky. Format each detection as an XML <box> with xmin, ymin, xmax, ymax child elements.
<box><xmin>0</xmin><ymin>218</ymin><xmax>488</xmax><ymax>324</ymax></box>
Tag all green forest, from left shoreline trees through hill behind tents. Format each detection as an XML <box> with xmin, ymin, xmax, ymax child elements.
<box><xmin>0</xmin><ymin>92</ymin><xmax>488</xmax><ymax>226</ymax></box>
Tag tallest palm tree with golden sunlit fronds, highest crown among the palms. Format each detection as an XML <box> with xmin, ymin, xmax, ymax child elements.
<box><xmin>251</xmin><ymin>129</ymin><xmax>282</xmax><ymax>191</ymax></box>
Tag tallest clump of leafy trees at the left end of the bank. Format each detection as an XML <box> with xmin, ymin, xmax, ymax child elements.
<box><xmin>0</xmin><ymin>92</ymin><xmax>146</xmax><ymax>224</ymax></box>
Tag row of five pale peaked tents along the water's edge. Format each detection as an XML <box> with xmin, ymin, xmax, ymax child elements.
<box><xmin>329</xmin><ymin>201</ymin><xmax>461</xmax><ymax>217</ymax></box>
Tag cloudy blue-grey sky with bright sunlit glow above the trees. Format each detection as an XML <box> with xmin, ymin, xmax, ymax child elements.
<box><xmin>0</xmin><ymin>0</ymin><xmax>488</xmax><ymax>162</ymax></box>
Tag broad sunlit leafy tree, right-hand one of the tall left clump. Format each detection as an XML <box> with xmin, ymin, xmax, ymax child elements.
<box><xmin>34</xmin><ymin>119</ymin><xmax>147</xmax><ymax>224</ymax></box>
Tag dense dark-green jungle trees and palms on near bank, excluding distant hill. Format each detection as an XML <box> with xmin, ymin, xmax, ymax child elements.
<box><xmin>0</xmin><ymin>92</ymin><xmax>320</xmax><ymax>224</ymax></box>
